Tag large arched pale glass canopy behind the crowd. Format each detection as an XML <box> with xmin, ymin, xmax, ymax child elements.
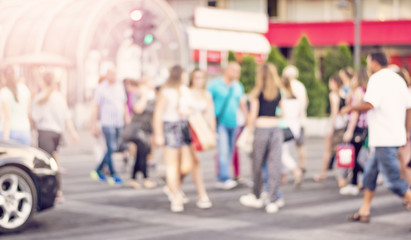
<box><xmin>0</xmin><ymin>0</ymin><xmax>188</xmax><ymax>104</ymax></box>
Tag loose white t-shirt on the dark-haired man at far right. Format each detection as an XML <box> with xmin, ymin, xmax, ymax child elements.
<box><xmin>364</xmin><ymin>69</ymin><xmax>411</xmax><ymax>147</ymax></box>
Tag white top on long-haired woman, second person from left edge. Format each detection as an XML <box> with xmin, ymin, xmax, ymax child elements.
<box><xmin>31</xmin><ymin>91</ymin><xmax>70</xmax><ymax>133</ymax></box>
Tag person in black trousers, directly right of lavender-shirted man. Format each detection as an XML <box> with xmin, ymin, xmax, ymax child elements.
<box><xmin>125</xmin><ymin>77</ymin><xmax>157</xmax><ymax>189</ymax></box>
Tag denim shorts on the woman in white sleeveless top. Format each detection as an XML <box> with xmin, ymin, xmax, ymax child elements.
<box><xmin>163</xmin><ymin>120</ymin><xmax>191</xmax><ymax>148</ymax></box>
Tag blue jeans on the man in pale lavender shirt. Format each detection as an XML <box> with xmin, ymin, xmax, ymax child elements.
<box><xmin>96</xmin><ymin>127</ymin><xmax>122</xmax><ymax>176</ymax></box>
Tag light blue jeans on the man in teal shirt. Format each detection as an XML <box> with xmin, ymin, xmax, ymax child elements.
<box><xmin>217</xmin><ymin>124</ymin><xmax>237</xmax><ymax>182</ymax></box>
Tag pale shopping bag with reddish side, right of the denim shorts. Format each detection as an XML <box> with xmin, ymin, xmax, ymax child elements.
<box><xmin>188</xmin><ymin>114</ymin><xmax>217</xmax><ymax>151</ymax></box>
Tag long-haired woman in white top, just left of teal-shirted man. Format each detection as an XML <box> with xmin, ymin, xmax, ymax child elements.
<box><xmin>183</xmin><ymin>69</ymin><xmax>216</xmax><ymax>208</ymax></box>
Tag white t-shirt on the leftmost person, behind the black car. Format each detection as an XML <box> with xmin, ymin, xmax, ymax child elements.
<box><xmin>0</xmin><ymin>83</ymin><xmax>31</xmax><ymax>131</ymax></box>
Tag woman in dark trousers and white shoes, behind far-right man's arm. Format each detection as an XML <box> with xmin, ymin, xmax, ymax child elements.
<box><xmin>340</xmin><ymin>67</ymin><xmax>368</xmax><ymax>196</ymax></box>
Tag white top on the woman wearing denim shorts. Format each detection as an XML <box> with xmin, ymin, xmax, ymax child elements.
<box><xmin>161</xmin><ymin>86</ymin><xmax>193</xmax><ymax>122</ymax></box>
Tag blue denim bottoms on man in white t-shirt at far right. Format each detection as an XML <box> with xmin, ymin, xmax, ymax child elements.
<box><xmin>364</xmin><ymin>147</ymin><xmax>408</xmax><ymax>197</ymax></box>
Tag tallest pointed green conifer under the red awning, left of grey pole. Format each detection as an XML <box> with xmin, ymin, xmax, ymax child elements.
<box><xmin>293</xmin><ymin>35</ymin><xmax>327</xmax><ymax>117</ymax></box>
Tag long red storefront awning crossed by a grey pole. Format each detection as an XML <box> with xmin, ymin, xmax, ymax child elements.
<box><xmin>265</xmin><ymin>20</ymin><xmax>411</xmax><ymax>47</ymax></box>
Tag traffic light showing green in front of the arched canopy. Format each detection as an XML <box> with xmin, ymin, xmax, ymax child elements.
<box><xmin>130</xmin><ymin>9</ymin><xmax>156</xmax><ymax>47</ymax></box>
